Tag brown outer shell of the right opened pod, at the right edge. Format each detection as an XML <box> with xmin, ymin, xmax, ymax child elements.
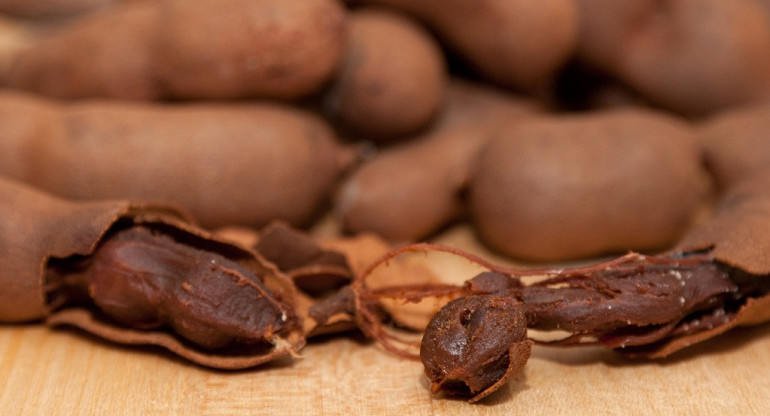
<box><xmin>520</xmin><ymin>172</ymin><xmax>770</xmax><ymax>358</ymax></box>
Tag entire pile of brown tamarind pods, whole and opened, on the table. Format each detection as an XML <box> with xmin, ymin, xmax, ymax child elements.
<box><xmin>0</xmin><ymin>0</ymin><xmax>770</xmax><ymax>400</ymax></box>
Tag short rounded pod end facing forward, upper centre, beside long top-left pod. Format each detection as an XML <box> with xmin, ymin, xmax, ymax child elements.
<box><xmin>324</xmin><ymin>8</ymin><xmax>447</xmax><ymax>141</ymax></box>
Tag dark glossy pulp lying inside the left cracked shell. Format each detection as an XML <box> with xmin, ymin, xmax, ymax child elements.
<box><xmin>58</xmin><ymin>226</ymin><xmax>298</xmax><ymax>350</ymax></box>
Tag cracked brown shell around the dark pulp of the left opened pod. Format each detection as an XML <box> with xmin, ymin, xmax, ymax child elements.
<box><xmin>0</xmin><ymin>178</ymin><xmax>305</xmax><ymax>369</ymax></box>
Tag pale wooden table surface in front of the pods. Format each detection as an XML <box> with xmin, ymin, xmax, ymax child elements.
<box><xmin>0</xmin><ymin>228</ymin><xmax>770</xmax><ymax>416</ymax></box>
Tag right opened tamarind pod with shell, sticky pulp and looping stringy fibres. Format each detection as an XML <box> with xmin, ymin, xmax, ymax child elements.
<box><xmin>340</xmin><ymin>169</ymin><xmax>770</xmax><ymax>401</ymax></box>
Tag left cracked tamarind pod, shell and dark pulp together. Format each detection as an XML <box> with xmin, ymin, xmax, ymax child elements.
<box><xmin>0</xmin><ymin>179</ymin><xmax>305</xmax><ymax>368</ymax></box>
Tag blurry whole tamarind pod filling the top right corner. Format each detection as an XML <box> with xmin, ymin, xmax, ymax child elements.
<box><xmin>577</xmin><ymin>0</ymin><xmax>770</xmax><ymax>115</ymax></box>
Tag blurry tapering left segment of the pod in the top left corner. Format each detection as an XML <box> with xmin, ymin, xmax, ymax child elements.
<box><xmin>5</xmin><ymin>1</ymin><xmax>162</xmax><ymax>100</ymax></box>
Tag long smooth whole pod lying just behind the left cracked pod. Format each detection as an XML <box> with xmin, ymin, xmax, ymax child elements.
<box><xmin>0</xmin><ymin>93</ymin><xmax>352</xmax><ymax>227</ymax></box>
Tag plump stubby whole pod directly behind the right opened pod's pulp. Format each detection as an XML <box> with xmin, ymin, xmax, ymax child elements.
<box><xmin>469</xmin><ymin>109</ymin><xmax>708</xmax><ymax>261</ymax></box>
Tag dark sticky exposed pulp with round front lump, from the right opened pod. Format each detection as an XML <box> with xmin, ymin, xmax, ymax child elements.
<box><xmin>420</xmin><ymin>247</ymin><xmax>770</xmax><ymax>402</ymax></box>
